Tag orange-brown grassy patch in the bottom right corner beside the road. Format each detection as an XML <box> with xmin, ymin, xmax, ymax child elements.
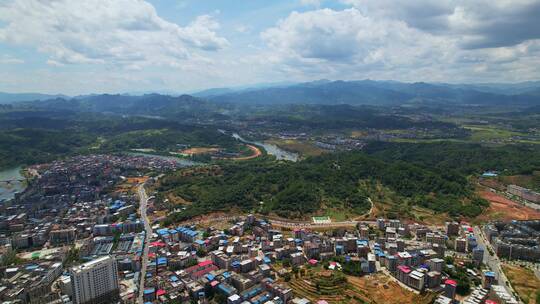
<box><xmin>503</xmin><ymin>264</ymin><xmax>540</xmax><ymax>304</ymax></box>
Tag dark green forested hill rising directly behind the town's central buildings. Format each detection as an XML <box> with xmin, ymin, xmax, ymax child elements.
<box><xmin>159</xmin><ymin>152</ymin><xmax>485</xmax><ymax>221</ymax></box>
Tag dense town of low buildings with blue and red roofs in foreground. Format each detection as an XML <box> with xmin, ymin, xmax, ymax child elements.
<box><xmin>0</xmin><ymin>155</ymin><xmax>540</xmax><ymax>304</ymax></box>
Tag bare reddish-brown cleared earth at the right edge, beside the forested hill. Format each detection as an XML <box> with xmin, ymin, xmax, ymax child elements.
<box><xmin>478</xmin><ymin>190</ymin><xmax>540</xmax><ymax>221</ymax></box>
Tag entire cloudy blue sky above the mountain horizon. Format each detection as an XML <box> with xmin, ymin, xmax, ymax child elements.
<box><xmin>0</xmin><ymin>0</ymin><xmax>540</xmax><ymax>95</ymax></box>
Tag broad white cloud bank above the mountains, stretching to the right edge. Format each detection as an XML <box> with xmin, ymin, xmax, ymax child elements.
<box><xmin>261</xmin><ymin>6</ymin><xmax>540</xmax><ymax>82</ymax></box>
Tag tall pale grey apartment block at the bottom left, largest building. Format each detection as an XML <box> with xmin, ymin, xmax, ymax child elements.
<box><xmin>70</xmin><ymin>256</ymin><xmax>119</xmax><ymax>304</ymax></box>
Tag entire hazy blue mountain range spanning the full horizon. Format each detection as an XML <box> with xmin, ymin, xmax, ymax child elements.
<box><xmin>4</xmin><ymin>80</ymin><xmax>540</xmax><ymax>108</ymax></box>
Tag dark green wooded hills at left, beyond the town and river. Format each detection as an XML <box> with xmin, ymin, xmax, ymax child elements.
<box><xmin>0</xmin><ymin>111</ymin><xmax>241</xmax><ymax>168</ymax></box>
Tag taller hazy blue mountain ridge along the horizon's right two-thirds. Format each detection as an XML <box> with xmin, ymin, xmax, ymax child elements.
<box><xmin>198</xmin><ymin>80</ymin><xmax>540</xmax><ymax>106</ymax></box>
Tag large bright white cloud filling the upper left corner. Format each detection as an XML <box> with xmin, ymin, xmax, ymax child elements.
<box><xmin>0</xmin><ymin>0</ymin><xmax>228</xmax><ymax>69</ymax></box>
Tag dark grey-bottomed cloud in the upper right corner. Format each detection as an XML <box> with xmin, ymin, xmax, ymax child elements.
<box><xmin>342</xmin><ymin>0</ymin><xmax>540</xmax><ymax>49</ymax></box>
